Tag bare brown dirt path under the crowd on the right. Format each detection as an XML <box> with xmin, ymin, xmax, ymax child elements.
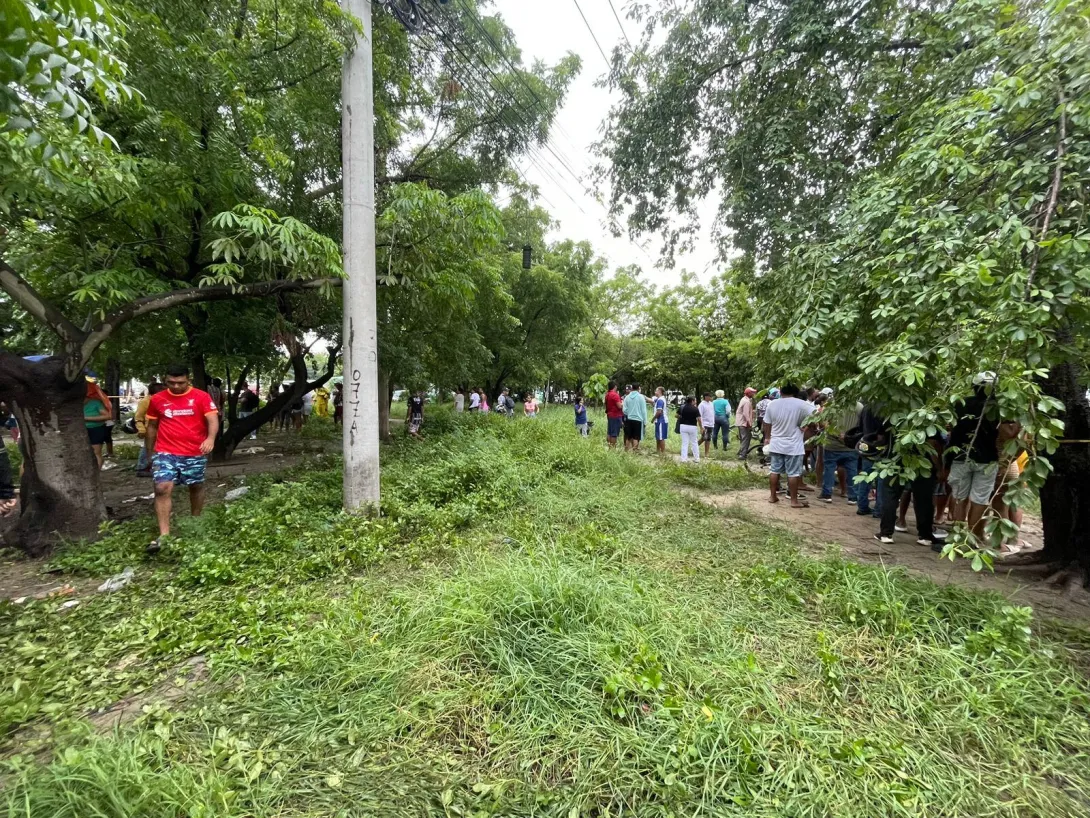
<box><xmin>701</xmin><ymin>489</ymin><xmax>1090</xmax><ymax>621</ymax></box>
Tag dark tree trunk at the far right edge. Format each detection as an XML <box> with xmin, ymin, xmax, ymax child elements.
<box><xmin>1041</xmin><ymin>363</ymin><xmax>1090</xmax><ymax>582</ymax></box>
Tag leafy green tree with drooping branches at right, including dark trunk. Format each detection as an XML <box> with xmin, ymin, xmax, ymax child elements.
<box><xmin>765</xmin><ymin>2</ymin><xmax>1090</xmax><ymax>588</ymax></box>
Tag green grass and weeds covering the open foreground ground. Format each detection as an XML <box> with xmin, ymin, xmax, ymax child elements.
<box><xmin>0</xmin><ymin>412</ymin><xmax>1090</xmax><ymax>818</ymax></box>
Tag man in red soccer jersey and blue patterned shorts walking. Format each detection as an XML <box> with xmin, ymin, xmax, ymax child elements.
<box><xmin>145</xmin><ymin>365</ymin><xmax>219</xmax><ymax>554</ymax></box>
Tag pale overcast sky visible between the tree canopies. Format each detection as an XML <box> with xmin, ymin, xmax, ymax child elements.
<box><xmin>490</xmin><ymin>0</ymin><xmax>717</xmax><ymax>286</ymax></box>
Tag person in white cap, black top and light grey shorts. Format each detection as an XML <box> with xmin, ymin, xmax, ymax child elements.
<box><xmin>947</xmin><ymin>372</ymin><xmax>1000</xmax><ymax>539</ymax></box>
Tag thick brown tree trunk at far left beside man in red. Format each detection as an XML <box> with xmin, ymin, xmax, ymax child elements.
<box><xmin>0</xmin><ymin>356</ymin><xmax>106</xmax><ymax>556</ymax></box>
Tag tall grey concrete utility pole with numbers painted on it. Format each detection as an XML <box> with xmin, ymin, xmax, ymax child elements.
<box><xmin>341</xmin><ymin>0</ymin><xmax>379</xmax><ymax>512</ymax></box>
